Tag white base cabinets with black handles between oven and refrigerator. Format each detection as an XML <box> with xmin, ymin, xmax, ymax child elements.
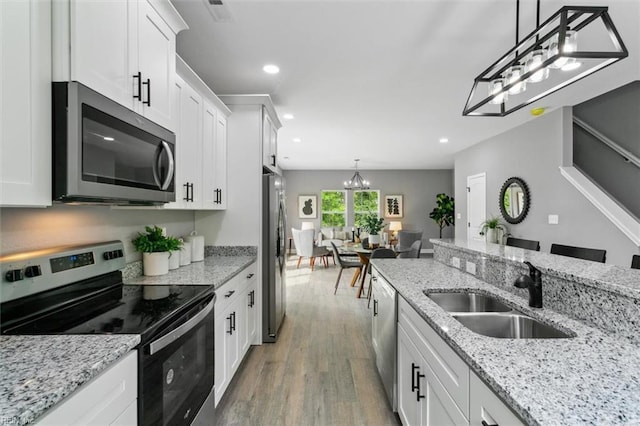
<box><xmin>214</xmin><ymin>263</ymin><xmax>257</xmax><ymax>405</ymax></box>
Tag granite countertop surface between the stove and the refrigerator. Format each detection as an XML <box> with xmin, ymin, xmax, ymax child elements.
<box><xmin>124</xmin><ymin>255</ymin><xmax>256</xmax><ymax>290</ymax></box>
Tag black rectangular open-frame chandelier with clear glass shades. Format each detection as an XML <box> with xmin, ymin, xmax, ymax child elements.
<box><xmin>462</xmin><ymin>0</ymin><xmax>629</xmax><ymax>117</ymax></box>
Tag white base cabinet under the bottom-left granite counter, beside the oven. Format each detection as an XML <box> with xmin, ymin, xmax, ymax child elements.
<box><xmin>36</xmin><ymin>350</ymin><xmax>138</xmax><ymax>426</ymax></box>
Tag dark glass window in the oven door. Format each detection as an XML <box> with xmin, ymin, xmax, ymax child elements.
<box><xmin>162</xmin><ymin>328</ymin><xmax>207</xmax><ymax>425</ymax></box>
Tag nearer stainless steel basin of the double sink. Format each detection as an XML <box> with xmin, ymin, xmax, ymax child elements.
<box><xmin>452</xmin><ymin>313</ymin><xmax>573</xmax><ymax>339</ymax></box>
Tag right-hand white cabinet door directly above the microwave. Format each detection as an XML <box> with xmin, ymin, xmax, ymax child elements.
<box><xmin>137</xmin><ymin>1</ymin><xmax>176</xmax><ymax>127</ymax></box>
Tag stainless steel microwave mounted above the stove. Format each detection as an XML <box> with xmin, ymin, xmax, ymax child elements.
<box><xmin>53</xmin><ymin>82</ymin><xmax>175</xmax><ymax>205</ymax></box>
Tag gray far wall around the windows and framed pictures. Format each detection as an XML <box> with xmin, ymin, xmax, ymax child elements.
<box><xmin>284</xmin><ymin>170</ymin><xmax>453</xmax><ymax>249</ymax></box>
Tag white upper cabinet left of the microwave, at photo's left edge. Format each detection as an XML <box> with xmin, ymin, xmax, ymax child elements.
<box><xmin>0</xmin><ymin>0</ymin><xmax>52</xmax><ymax>207</ymax></box>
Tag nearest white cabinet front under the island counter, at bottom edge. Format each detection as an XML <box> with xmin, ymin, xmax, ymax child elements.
<box><xmin>469</xmin><ymin>373</ymin><xmax>524</xmax><ymax>426</ymax></box>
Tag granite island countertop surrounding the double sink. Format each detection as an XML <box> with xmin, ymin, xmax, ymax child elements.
<box><xmin>372</xmin><ymin>259</ymin><xmax>640</xmax><ymax>425</ymax></box>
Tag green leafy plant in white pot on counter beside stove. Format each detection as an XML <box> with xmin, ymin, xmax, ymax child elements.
<box><xmin>131</xmin><ymin>225</ymin><xmax>182</xmax><ymax>276</ymax></box>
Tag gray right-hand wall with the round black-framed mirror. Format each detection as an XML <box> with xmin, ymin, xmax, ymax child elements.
<box><xmin>455</xmin><ymin>110</ymin><xmax>640</xmax><ymax>267</ymax></box>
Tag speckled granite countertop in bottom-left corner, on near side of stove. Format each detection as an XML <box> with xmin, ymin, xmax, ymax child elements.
<box><xmin>0</xmin><ymin>334</ymin><xmax>140</xmax><ymax>425</ymax></box>
